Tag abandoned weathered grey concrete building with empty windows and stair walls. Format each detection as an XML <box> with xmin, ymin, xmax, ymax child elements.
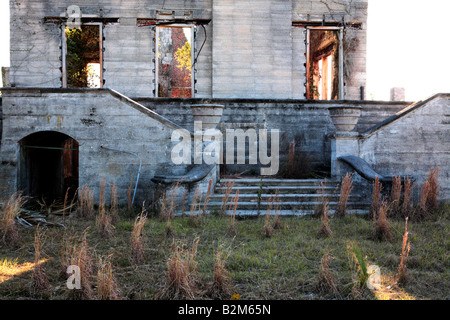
<box><xmin>0</xmin><ymin>0</ymin><xmax>450</xmax><ymax>212</ymax></box>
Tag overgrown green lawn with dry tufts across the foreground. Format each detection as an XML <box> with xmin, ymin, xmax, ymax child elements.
<box><xmin>0</xmin><ymin>206</ymin><xmax>450</xmax><ymax>300</ymax></box>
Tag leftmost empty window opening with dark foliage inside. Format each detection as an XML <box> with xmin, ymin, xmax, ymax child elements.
<box><xmin>63</xmin><ymin>24</ymin><xmax>103</xmax><ymax>88</ymax></box>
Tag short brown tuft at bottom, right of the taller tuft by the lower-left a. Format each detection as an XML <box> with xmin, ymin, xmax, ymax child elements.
<box><xmin>97</xmin><ymin>256</ymin><xmax>121</xmax><ymax>300</ymax></box>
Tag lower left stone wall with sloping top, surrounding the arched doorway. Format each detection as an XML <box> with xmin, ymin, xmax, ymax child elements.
<box><xmin>0</xmin><ymin>89</ymin><xmax>186</xmax><ymax>203</ymax></box>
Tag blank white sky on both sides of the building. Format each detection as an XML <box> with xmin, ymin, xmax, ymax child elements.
<box><xmin>0</xmin><ymin>0</ymin><xmax>450</xmax><ymax>101</ymax></box>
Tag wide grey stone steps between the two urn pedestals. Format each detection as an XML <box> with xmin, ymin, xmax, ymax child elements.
<box><xmin>208</xmin><ymin>179</ymin><xmax>370</xmax><ymax>215</ymax></box>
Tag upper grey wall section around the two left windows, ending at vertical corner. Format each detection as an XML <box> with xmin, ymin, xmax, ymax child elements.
<box><xmin>10</xmin><ymin>0</ymin><xmax>211</xmax><ymax>97</ymax></box>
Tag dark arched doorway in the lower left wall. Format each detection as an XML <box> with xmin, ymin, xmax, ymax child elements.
<box><xmin>18</xmin><ymin>131</ymin><xmax>79</xmax><ymax>203</ymax></box>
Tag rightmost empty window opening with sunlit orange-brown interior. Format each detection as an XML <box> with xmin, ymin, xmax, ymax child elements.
<box><xmin>306</xmin><ymin>28</ymin><xmax>343</xmax><ymax>100</ymax></box>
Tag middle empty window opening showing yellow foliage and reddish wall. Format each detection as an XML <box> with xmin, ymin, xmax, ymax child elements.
<box><xmin>156</xmin><ymin>26</ymin><xmax>194</xmax><ymax>98</ymax></box>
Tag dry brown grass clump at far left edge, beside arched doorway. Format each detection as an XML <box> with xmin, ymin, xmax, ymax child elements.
<box><xmin>0</xmin><ymin>193</ymin><xmax>26</xmax><ymax>246</ymax></box>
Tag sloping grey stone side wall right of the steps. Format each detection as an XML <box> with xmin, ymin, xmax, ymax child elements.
<box><xmin>359</xmin><ymin>94</ymin><xmax>450</xmax><ymax>200</ymax></box>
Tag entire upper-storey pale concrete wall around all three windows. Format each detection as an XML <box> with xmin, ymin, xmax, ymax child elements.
<box><xmin>10</xmin><ymin>0</ymin><xmax>367</xmax><ymax>99</ymax></box>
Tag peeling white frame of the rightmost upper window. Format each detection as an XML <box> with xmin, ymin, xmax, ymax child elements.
<box><xmin>305</xmin><ymin>26</ymin><xmax>345</xmax><ymax>100</ymax></box>
